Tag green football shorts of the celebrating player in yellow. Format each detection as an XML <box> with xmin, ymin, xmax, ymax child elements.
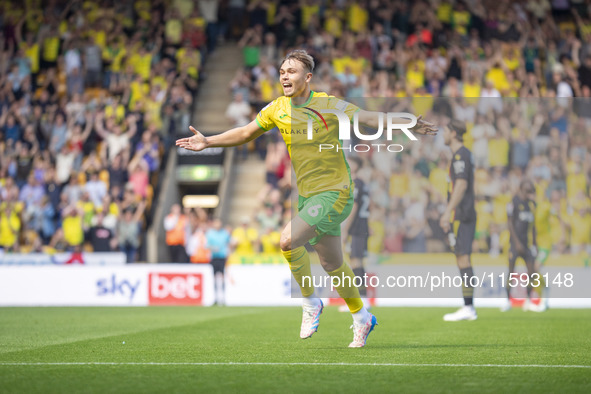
<box><xmin>298</xmin><ymin>188</ymin><xmax>353</xmax><ymax>245</ymax></box>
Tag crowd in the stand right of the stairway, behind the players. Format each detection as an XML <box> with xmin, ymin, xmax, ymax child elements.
<box><xmin>230</xmin><ymin>0</ymin><xmax>591</xmax><ymax>256</ymax></box>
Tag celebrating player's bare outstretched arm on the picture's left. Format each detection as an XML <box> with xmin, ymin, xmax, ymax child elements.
<box><xmin>176</xmin><ymin>120</ymin><xmax>266</xmax><ymax>152</ymax></box>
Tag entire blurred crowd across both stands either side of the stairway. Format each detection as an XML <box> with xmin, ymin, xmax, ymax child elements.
<box><xmin>0</xmin><ymin>0</ymin><xmax>591</xmax><ymax>261</ymax></box>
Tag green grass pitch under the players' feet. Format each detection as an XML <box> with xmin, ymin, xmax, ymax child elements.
<box><xmin>0</xmin><ymin>307</ymin><xmax>591</xmax><ymax>393</ymax></box>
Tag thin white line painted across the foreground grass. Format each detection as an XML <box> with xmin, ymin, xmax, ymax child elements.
<box><xmin>0</xmin><ymin>362</ymin><xmax>591</xmax><ymax>369</ymax></box>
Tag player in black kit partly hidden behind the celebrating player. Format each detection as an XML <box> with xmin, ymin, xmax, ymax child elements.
<box><xmin>343</xmin><ymin>156</ymin><xmax>370</xmax><ymax>311</ymax></box>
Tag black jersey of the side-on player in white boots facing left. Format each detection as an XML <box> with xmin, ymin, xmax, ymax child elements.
<box><xmin>447</xmin><ymin>146</ymin><xmax>476</xmax><ymax>222</ymax></box>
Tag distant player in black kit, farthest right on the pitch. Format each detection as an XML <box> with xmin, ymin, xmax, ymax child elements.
<box><xmin>501</xmin><ymin>179</ymin><xmax>546</xmax><ymax>312</ymax></box>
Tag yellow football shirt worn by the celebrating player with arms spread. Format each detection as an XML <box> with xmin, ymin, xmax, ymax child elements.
<box><xmin>256</xmin><ymin>91</ymin><xmax>359</xmax><ymax>197</ymax></box>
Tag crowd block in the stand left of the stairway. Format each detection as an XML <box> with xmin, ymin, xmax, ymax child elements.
<box><xmin>0</xmin><ymin>0</ymin><xmax>209</xmax><ymax>262</ymax></box>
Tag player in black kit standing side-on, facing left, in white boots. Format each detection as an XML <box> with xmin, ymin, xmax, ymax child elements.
<box><xmin>439</xmin><ymin>119</ymin><xmax>478</xmax><ymax>321</ymax></box>
